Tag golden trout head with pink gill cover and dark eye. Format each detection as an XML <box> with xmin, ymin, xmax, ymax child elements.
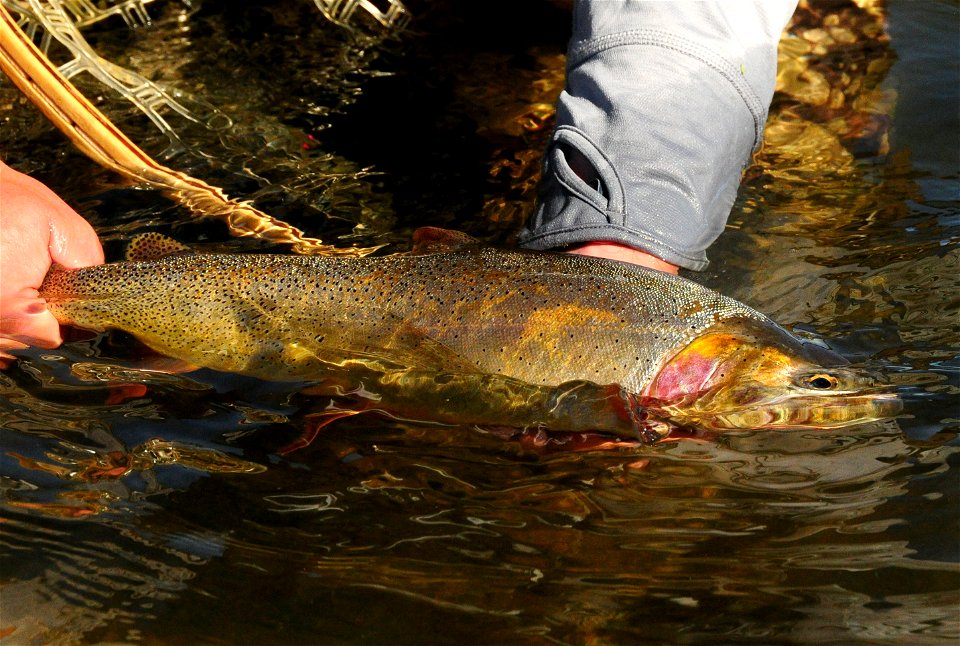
<box><xmin>645</xmin><ymin>318</ymin><xmax>901</xmax><ymax>431</ymax></box>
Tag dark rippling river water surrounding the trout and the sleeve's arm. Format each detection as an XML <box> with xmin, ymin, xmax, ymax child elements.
<box><xmin>0</xmin><ymin>0</ymin><xmax>960</xmax><ymax>644</ymax></box>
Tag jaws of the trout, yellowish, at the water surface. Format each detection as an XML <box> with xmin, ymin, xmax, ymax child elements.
<box><xmin>677</xmin><ymin>392</ymin><xmax>903</xmax><ymax>431</ymax></box>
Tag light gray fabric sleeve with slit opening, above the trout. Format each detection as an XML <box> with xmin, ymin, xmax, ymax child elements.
<box><xmin>520</xmin><ymin>0</ymin><xmax>797</xmax><ymax>270</ymax></box>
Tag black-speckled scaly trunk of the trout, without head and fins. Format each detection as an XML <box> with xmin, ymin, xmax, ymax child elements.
<box><xmin>43</xmin><ymin>247</ymin><xmax>764</xmax><ymax>392</ymax></box>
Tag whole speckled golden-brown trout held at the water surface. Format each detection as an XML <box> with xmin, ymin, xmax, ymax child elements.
<box><xmin>40</xmin><ymin>228</ymin><xmax>899</xmax><ymax>442</ymax></box>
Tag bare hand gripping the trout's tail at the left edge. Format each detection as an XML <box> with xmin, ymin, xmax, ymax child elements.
<box><xmin>0</xmin><ymin>162</ymin><xmax>103</xmax><ymax>368</ymax></box>
